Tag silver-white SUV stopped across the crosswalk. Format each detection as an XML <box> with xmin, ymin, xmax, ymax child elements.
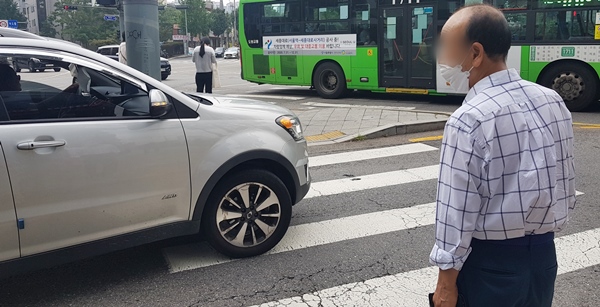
<box><xmin>0</xmin><ymin>37</ymin><xmax>310</xmax><ymax>275</ymax></box>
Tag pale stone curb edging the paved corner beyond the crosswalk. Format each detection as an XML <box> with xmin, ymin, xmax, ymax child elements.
<box><xmin>308</xmin><ymin>119</ymin><xmax>448</xmax><ymax>146</ymax></box>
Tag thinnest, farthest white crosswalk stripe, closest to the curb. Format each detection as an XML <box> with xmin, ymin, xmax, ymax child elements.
<box><xmin>308</xmin><ymin>143</ymin><xmax>439</xmax><ymax>167</ymax></box>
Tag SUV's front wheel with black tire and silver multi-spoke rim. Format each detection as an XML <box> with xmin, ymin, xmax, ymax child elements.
<box><xmin>202</xmin><ymin>169</ymin><xmax>292</xmax><ymax>258</ymax></box>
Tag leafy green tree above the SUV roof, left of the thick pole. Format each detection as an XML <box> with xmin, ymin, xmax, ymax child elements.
<box><xmin>48</xmin><ymin>0</ymin><xmax>119</xmax><ymax>48</ymax></box>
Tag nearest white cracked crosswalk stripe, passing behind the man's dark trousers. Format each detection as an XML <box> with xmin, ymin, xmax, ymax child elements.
<box><xmin>252</xmin><ymin>228</ymin><xmax>600</xmax><ymax>307</ymax></box>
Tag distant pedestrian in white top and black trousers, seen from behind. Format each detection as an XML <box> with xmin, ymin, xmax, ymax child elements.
<box><xmin>192</xmin><ymin>37</ymin><xmax>217</xmax><ymax>93</ymax></box>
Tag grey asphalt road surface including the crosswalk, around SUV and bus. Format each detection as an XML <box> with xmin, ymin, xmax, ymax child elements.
<box><xmin>0</xmin><ymin>59</ymin><xmax>600</xmax><ymax>307</ymax></box>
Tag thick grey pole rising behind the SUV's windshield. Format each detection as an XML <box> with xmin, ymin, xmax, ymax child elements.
<box><xmin>123</xmin><ymin>0</ymin><xmax>160</xmax><ymax>80</ymax></box>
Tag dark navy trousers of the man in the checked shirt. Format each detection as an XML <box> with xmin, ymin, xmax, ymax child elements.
<box><xmin>457</xmin><ymin>233</ymin><xmax>558</xmax><ymax>307</ymax></box>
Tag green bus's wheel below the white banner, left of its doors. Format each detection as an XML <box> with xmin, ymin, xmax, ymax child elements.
<box><xmin>313</xmin><ymin>62</ymin><xmax>346</xmax><ymax>99</ymax></box>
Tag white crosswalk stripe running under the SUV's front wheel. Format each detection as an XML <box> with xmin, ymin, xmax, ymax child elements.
<box><xmin>163</xmin><ymin>203</ymin><xmax>435</xmax><ymax>273</ymax></box>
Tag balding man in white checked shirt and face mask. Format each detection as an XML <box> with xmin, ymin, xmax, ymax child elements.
<box><xmin>430</xmin><ymin>5</ymin><xmax>575</xmax><ymax>307</ymax></box>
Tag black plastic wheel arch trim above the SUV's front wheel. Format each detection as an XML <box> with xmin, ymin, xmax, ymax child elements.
<box><xmin>192</xmin><ymin>150</ymin><xmax>299</xmax><ymax>221</ymax></box>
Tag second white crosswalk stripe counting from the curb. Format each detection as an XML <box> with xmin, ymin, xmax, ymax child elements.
<box><xmin>304</xmin><ymin>165</ymin><xmax>439</xmax><ymax>198</ymax></box>
